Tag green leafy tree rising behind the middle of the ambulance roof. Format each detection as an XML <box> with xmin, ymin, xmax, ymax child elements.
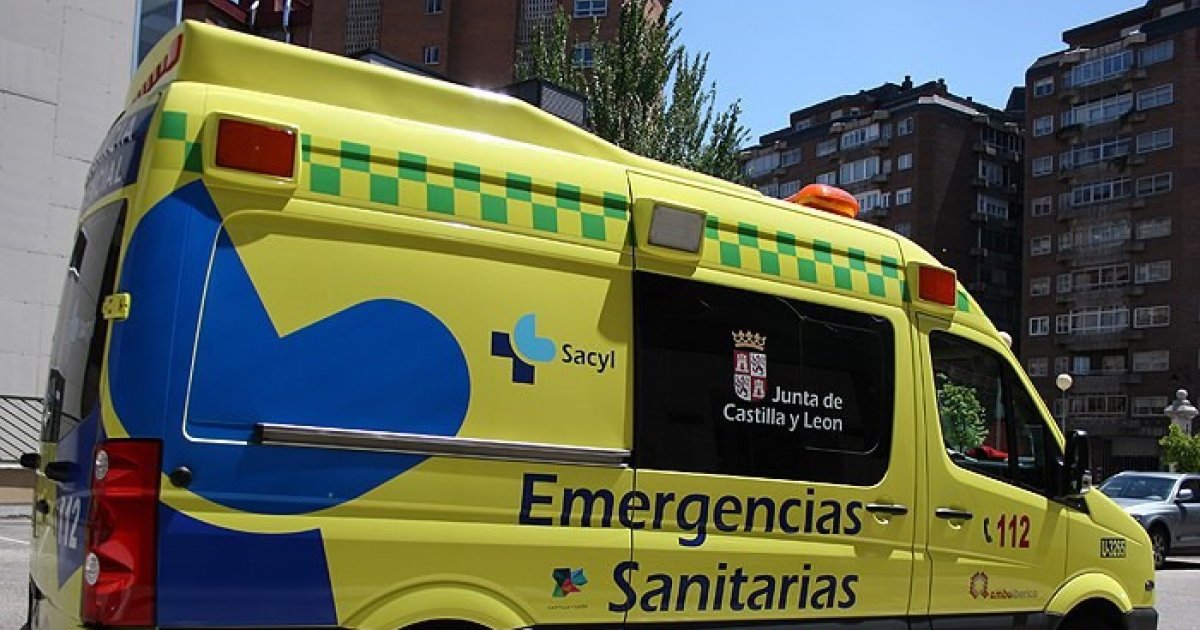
<box><xmin>517</xmin><ymin>0</ymin><xmax>749</xmax><ymax>181</ymax></box>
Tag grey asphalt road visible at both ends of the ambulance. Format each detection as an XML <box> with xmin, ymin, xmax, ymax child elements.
<box><xmin>0</xmin><ymin>511</ymin><xmax>1200</xmax><ymax>630</ymax></box>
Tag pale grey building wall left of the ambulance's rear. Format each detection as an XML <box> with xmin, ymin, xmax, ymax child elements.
<box><xmin>0</xmin><ymin>0</ymin><xmax>136</xmax><ymax>396</ymax></box>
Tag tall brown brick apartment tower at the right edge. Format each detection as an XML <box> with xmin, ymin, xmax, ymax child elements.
<box><xmin>1021</xmin><ymin>0</ymin><xmax>1200</xmax><ymax>476</ymax></box>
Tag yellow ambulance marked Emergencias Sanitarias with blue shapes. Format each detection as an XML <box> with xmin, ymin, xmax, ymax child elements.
<box><xmin>25</xmin><ymin>23</ymin><xmax>1157</xmax><ymax>630</ymax></box>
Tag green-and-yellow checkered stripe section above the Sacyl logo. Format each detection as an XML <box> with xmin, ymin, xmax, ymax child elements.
<box><xmin>301</xmin><ymin>134</ymin><xmax>629</xmax><ymax>248</ymax></box>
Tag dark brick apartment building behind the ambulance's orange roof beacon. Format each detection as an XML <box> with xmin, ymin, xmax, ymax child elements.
<box><xmin>742</xmin><ymin>77</ymin><xmax>1025</xmax><ymax>337</ymax></box>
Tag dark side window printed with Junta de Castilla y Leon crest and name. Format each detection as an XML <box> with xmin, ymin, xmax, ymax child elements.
<box><xmin>634</xmin><ymin>274</ymin><xmax>895</xmax><ymax>485</ymax></box>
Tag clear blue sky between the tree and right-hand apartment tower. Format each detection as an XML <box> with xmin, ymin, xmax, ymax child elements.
<box><xmin>671</xmin><ymin>0</ymin><xmax>1145</xmax><ymax>144</ymax></box>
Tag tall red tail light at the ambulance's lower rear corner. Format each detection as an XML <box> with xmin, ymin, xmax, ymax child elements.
<box><xmin>82</xmin><ymin>439</ymin><xmax>162</xmax><ymax>626</ymax></box>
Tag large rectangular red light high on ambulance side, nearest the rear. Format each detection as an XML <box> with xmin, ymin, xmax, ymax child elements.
<box><xmin>216</xmin><ymin>119</ymin><xmax>296</xmax><ymax>179</ymax></box>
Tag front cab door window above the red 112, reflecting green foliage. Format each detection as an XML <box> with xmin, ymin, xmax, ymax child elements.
<box><xmin>929</xmin><ymin>331</ymin><xmax>1057</xmax><ymax>492</ymax></box>
